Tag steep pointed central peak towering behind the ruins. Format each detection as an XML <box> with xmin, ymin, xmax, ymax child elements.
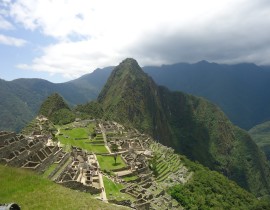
<box><xmin>98</xmin><ymin>59</ymin><xmax>168</xmax><ymax>136</ymax></box>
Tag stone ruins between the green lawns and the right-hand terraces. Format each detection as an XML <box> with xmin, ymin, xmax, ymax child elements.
<box><xmin>99</xmin><ymin>123</ymin><xmax>186</xmax><ymax>209</ymax></box>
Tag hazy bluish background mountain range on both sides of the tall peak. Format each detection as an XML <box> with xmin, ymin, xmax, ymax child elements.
<box><xmin>0</xmin><ymin>61</ymin><xmax>270</xmax><ymax>131</ymax></box>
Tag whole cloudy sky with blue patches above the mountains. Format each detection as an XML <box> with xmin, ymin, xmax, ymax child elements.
<box><xmin>0</xmin><ymin>0</ymin><xmax>270</xmax><ymax>82</ymax></box>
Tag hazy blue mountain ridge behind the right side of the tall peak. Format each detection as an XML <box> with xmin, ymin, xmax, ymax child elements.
<box><xmin>143</xmin><ymin>61</ymin><xmax>270</xmax><ymax>129</ymax></box>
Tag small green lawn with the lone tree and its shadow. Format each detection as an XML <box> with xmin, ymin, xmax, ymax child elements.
<box><xmin>97</xmin><ymin>155</ymin><xmax>126</xmax><ymax>171</ymax></box>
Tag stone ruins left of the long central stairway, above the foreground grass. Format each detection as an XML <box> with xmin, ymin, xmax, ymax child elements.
<box><xmin>0</xmin><ymin>131</ymin><xmax>101</xmax><ymax>194</ymax></box>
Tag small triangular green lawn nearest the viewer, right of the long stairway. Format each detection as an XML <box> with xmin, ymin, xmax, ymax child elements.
<box><xmin>103</xmin><ymin>176</ymin><xmax>134</xmax><ymax>201</ymax></box>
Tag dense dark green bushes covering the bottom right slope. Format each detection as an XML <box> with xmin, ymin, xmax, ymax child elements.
<box><xmin>168</xmin><ymin>157</ymin><xmax>270</xmax><ymax>210</ymax></box>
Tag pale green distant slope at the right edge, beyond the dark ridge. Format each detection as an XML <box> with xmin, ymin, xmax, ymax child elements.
<box><xmin>248</xmin><ymin>121</ymin><xmax>270</xmax><ymax>160</ymax></box>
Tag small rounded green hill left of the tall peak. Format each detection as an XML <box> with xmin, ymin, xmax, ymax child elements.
<box><xmin>39</xmin><ymin>93</ymin><xmax>75</xmax><ymax>124</ymax></box>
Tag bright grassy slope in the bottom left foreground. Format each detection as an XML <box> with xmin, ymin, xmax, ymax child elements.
<box><xmin>0</xmin><ymin>165</ymin><xmax>126</xmax><ymax>210</ymax></box>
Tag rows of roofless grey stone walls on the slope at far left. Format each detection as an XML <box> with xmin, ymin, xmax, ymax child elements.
<box><xmin>0</xmin><ymin>132</ymin><xmax>65</xmax><ymax>173</ymax></box>
